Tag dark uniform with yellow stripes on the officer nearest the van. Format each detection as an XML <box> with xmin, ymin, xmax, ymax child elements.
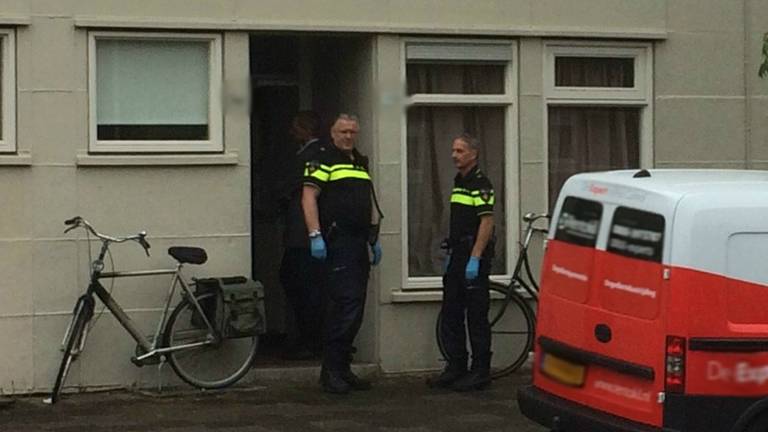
<box><xmin>440</xmin><ymin>166</ymin><xmax>495</xmax><ymax>370</ymax></box>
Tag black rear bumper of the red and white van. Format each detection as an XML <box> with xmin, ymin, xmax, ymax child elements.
<box><xmin>517</xmin><ymin>386</ymin><xmax>675</xmax><ymax>432</ymax></box>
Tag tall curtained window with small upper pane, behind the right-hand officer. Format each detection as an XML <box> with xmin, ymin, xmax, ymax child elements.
<box><xmin>403</xmin><ymin>41</ymin><xmax>514</xmax><ymax>288</ymax></box>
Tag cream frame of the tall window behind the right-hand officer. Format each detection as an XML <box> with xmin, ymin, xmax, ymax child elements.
<box><xmin>400</xmin><ymin>38</ymin><xmax>520</xmax><ymax>291</ymax></box>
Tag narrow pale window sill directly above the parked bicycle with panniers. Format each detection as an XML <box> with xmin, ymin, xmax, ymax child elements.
<box><xmin>77</xmin><ymin>152</ymin><xmax>240</xmax><ymax>166</ymax></box>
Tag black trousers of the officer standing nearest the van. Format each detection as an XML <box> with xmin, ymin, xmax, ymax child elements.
<box><xmin>440</xmin><ymin>248</ymin><xmax>491</xmax><ymax>369</ymax></box>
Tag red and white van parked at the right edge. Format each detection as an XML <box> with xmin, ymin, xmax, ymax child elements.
<box><xmin>518</xmin><ymin>170</ymin><xmax>768</xmax><ymax>432</ymax></box>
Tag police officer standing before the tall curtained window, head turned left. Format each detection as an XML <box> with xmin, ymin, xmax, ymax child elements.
<box><xmin>428</xmin><ymin>134</ymin><xmax>495</xmax><ymax>391</ymax></box>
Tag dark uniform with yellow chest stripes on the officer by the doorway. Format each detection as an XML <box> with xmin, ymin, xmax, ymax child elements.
<box><xmin>304</xmin><ymin>145</ymin><xmax>372</xmax><ymax>372</ymax></box>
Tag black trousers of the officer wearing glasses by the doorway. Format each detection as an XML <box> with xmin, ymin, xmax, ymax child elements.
<box><xmin>323</xmin><ymin>235</ymin><xmax>371</xmax><ymax>371</ymax></box>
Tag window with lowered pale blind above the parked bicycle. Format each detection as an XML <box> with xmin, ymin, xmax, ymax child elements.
<box><xmin>89</xmin><ymin>32</ymin><xmax>223</xmax><ymax>153</ymax></box>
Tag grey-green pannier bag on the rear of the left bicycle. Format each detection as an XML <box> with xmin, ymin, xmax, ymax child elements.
<box><xmin>219</xmin><ymin>276</ymin><xmax>265</xmax><ymax>338</ymax></box>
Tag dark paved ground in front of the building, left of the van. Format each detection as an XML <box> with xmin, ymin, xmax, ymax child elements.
<box><xmin>0</xmin><ymin>373</ymin><xmax>544</xmax><ymax>432</ymax></box>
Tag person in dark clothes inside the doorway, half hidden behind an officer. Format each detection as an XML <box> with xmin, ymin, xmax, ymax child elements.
<box><xmin>280</xmin><ymin>111</ymin><xmax>326</xmax><ymax>360</ymax></box>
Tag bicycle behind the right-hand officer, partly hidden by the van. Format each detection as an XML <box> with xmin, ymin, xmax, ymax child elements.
<box><xmin>435</xmin><ymin>213</ymin><xmax>549</xmax><ymax>379</ymax></box>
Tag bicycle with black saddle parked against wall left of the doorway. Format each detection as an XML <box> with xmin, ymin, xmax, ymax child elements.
<box><xmin>45</xmin><ymin>216</ymin><xmax>258</xmax><ymax>404</ymax></box>
